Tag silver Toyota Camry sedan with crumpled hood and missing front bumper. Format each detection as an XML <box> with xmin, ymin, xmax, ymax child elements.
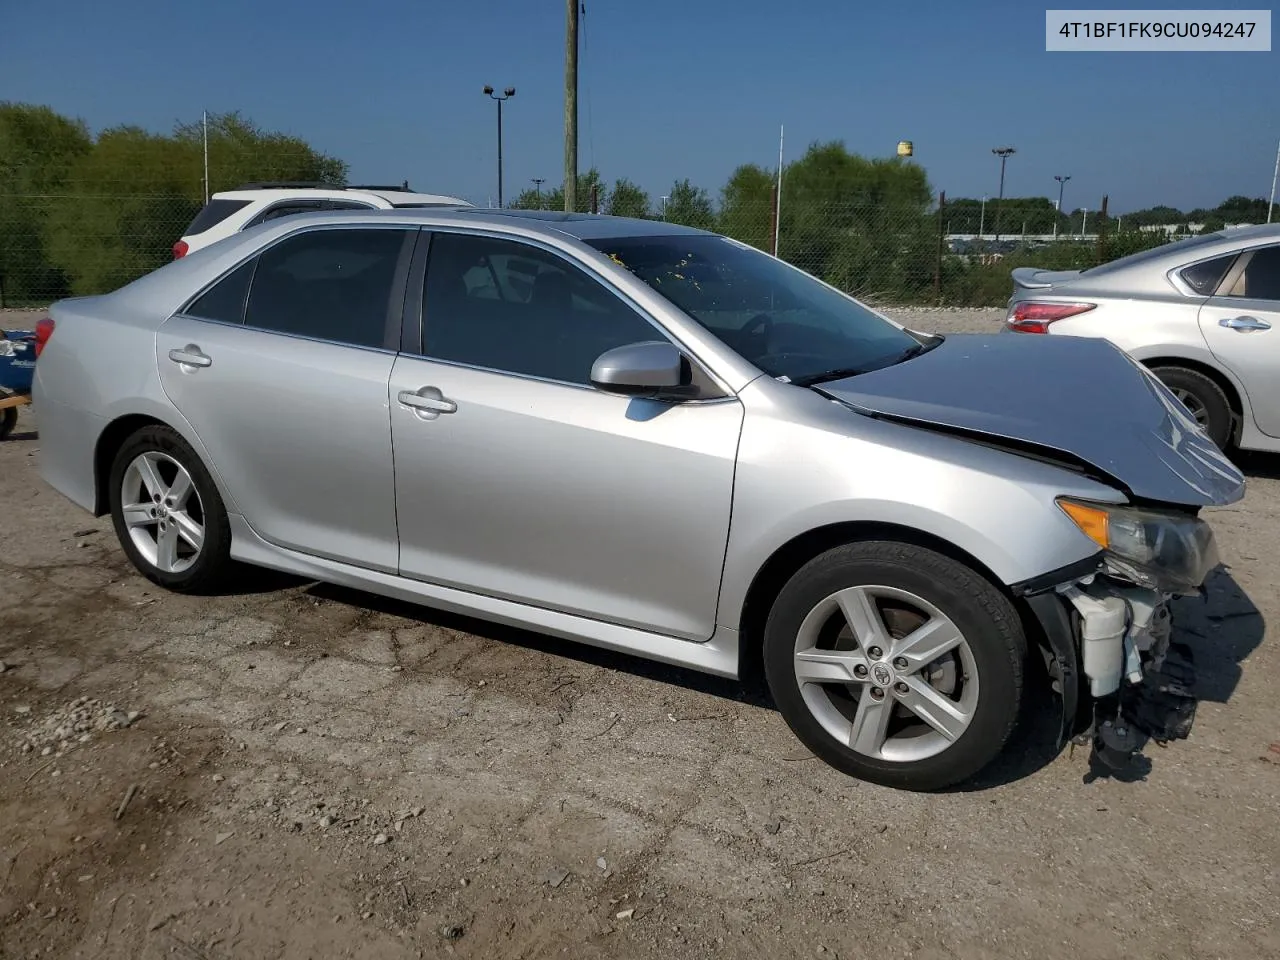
<box><xmin>33</xmin><ymin>209</ymin><xmax>1244</xmax><ymax>790</ymax></box>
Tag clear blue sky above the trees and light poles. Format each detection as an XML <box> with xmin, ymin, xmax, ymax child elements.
<box><xmin>0</xmin><ymin>0</ymin><xmax>1280</xmax><ymax>212</ymax></box>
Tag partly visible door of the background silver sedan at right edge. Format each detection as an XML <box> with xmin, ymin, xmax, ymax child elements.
<box><xmin>1199</xmin><ymin>241</ymin><xmax>1280</xmax><ymax>436</ymax></box>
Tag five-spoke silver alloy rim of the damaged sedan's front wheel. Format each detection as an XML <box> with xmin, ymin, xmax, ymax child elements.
<box><xmin>794</xmin><ymin>586</ymin><xmax>978</xmax><ymax>763</ymax></box>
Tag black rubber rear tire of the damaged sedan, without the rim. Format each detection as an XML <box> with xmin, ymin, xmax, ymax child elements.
<box><xmin>108</xmin><ymin>426</ymin><xmax>230</xmax><ymax>593</ymax></box>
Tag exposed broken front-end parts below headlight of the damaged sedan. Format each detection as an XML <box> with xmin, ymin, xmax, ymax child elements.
<box><xmin>1024</xmin><ymin>550</ymin><xmax>1217</xmax><ymax>776</ymax></box>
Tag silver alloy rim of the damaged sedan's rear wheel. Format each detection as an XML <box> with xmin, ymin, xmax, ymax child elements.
<box><xmin>120</xmin><ymin>451</ymin><xmax>205</xmax><ymax>573</ymax></box>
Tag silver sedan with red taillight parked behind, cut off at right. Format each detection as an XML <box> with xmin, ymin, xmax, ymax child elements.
<box><xmin>1006</xmin><ymin>224</ymin><xmax>1280</xmax><ymax>452</ymax></box>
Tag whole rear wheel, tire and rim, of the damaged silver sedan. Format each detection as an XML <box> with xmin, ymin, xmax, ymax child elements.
<box><xmin>109</xmin><ymin>426</ymin><xmax>233</xmax><ymax>593</ymax></box>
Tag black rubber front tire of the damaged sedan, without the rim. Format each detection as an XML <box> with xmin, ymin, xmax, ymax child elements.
<box><xmin>764</xmin><ymin>541</ymin><xmax>1027</xmax><ymax>790</ymax></box>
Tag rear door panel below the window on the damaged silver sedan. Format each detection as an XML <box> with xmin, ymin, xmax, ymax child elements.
<box><xmin>156</xmin><ymin>316</ymin><xmax>397</xmax><ymax>571</ymax></box>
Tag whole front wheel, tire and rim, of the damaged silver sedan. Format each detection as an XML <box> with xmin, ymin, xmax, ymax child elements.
<box><xmin>764</xmin><ymin>541</ymin><xmax>1027</xmax><ymax>791</ymax></box>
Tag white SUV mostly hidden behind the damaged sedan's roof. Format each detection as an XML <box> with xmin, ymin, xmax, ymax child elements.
<box><xmin>173</xmin><ymin>182</ymin><xmax>471</xmax><ymax>260</ymax></box>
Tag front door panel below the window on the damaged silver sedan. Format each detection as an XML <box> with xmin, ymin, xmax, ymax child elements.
<box><xmin>390</xmin><ymin>356</ymin><xmax>742</xmax><ymax>640</ymax></box>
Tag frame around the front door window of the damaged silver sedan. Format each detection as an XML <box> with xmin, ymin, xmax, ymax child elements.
<box><xmin>401</xmin><ymin>225</ymin><xmax>737</xmax><ymax>403</ymax></box>
